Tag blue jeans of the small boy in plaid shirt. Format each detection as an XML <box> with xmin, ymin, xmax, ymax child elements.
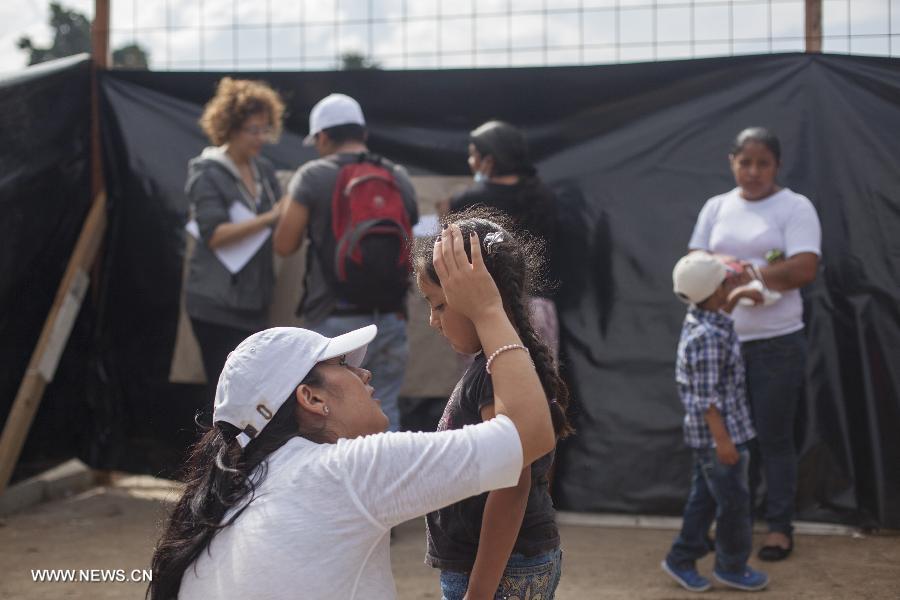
<box><xmin>666</xmin><ymin>444</ymin><xmax>753</xmax><ymax>573</ymax></box>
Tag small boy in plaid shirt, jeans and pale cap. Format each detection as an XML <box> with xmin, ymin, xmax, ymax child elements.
<box><xmin>662</xmin><ymin>252</ymin><xmax>769</xmax><ymax>592</ymax></box>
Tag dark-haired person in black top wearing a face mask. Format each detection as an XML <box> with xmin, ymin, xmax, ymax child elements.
<box><xmin>441</xmin><ymin>121</ymin><xmax>559</xmax><ymax>357</ymax></box>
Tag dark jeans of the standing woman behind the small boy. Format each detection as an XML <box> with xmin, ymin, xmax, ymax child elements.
<box><xmin>741</xmin><ymin>331</ymin><xmax>806</xmax><ymax>535</ymax></box>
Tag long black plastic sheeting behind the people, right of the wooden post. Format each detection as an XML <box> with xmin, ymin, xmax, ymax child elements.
<box><xmin>3</xmin><ymin>55</ymin><xmax>900</xmax><ymax>528</ymax></box>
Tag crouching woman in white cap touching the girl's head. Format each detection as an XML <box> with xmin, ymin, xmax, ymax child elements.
<box><xmin>149</xmin><ymin>226</ymin><xmax>556</xmax><ymax>600</ymax></box>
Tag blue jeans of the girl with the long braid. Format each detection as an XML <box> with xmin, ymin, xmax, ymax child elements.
<box><xmin>441</xmin><ymin>548</ymin><xmax>562</xmax><ymax>600</ymax></box>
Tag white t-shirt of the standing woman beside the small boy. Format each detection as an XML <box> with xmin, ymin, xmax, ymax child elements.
<box><xmin>688</xmin><ymin>188</ymin><xmax>822</xmax><ymax>342</ymax></box>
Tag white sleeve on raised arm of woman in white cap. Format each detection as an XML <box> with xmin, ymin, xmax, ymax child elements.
<box><xmin>332</xmin><ymin>415</ymin><xmax>522</xmax><ymax>528</ymax></box>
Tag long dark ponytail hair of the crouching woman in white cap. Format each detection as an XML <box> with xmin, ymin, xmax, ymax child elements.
<box><xmin>147</xmin><ymin>368</ymin><xmax>326</xmax><ymax>600</ymax></box>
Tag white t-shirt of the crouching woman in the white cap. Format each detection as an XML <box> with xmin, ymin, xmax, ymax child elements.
<box><xmin>178</xmin><ymin>415</ymin><xmax>522</xmax><ymax>600</ymax></box>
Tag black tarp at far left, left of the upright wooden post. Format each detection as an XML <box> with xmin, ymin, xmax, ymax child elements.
<box><xmin>0</xmin><ymin>55</ymin><xmax>91</xmax><ymax>478</ymax></box>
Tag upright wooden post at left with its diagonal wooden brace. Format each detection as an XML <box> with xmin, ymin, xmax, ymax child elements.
<box><xmin>0</xmin><ymin>0</ymin><xmax>109</xmax><ymax>494</ymax></box>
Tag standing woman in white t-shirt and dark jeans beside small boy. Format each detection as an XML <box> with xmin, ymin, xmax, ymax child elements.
<box><xmin>689</xmin><ymin>127</ymin><xmax>822</xmax><ymax>560</ymax></box>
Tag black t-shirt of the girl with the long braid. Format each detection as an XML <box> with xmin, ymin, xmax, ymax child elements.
<box><xmin>425</xmin><ymin>353</ymin><xmax>559</xmax><ymax>572</ymax></box>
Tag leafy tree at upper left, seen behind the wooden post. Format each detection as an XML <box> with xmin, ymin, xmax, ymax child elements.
<box><xmin>16</xmin><ymin>2</ymin><xmax>149</xmax><ymax>69</ymax></box>
